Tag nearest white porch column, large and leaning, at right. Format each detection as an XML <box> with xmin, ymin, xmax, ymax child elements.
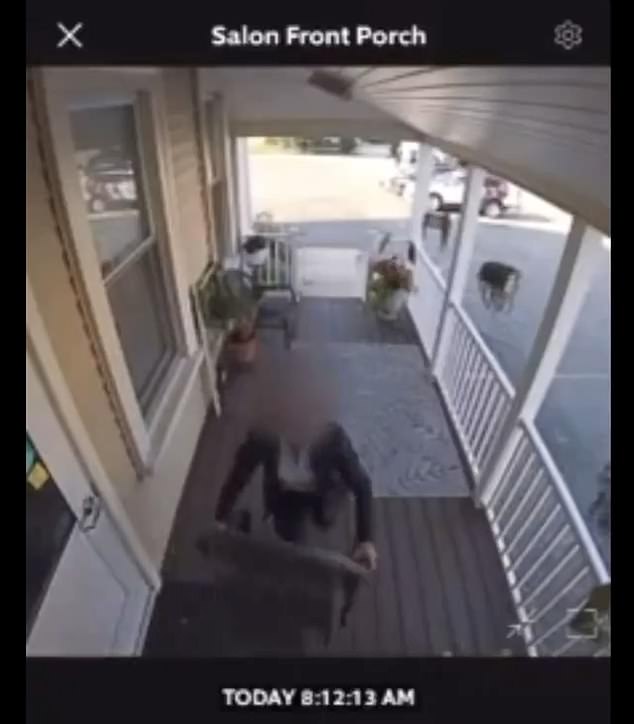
<box><xmin>476</xmin><ymin>218</ymin><xmax>602</xmax><ymax>502</ymax></box>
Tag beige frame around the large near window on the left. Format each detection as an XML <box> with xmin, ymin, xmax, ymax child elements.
<box><xmin>34</xmin><ymin>68</ymin><xmax>198</xmax><ymax>464</ymax></box>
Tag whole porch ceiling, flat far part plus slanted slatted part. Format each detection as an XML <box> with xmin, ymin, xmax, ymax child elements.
<box><xmin>203</xmin><ymin>66</ymin><xmax>610</xmax><ymax>235</ymax></box>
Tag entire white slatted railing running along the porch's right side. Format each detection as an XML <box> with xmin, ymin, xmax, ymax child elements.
<box><xmin>409</xmin><ymin>249</ymin><xmax>610</xmax><ymax>656</ymax></box>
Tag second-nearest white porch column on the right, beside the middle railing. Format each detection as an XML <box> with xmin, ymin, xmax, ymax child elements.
<box><xmin>431</xmin><ymin>166</ymin><xmax>484</xmax><ymax>375</ymax></box>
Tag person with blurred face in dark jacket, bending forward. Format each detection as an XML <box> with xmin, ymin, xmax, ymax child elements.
<box><xmin>216</xmin><ymin>362</ymin><xmax>377</xmax><ymax>570</ymax></box>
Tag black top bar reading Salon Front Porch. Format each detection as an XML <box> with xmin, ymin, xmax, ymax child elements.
<box><xmin>27</xmin><ymin>0</ymin><xmax>610</xmax><ymax>66</ymax></box>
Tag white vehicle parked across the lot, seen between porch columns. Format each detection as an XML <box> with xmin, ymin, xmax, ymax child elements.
<box><xmin>396</xmin><ymin>169</ymin><xmax>515</xmax><ymax>219</ymax></box>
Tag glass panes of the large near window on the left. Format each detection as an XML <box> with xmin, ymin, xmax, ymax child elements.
<box><xmin>71</xmin><ymin>103</ymin><xmax>176</xmax><ymax>418</ymax></box>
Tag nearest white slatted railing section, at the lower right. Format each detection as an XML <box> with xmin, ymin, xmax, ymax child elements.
<box><xmin>485</xmin><ymin>422</ymin><xmax>610</xmax><ymax>656</ymax></box>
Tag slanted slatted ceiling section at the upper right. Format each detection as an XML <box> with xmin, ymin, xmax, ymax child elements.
<box><xmin>329</xmin><ymin>67</ymin><xmax>610</xmax><ymax>235</ymax></box>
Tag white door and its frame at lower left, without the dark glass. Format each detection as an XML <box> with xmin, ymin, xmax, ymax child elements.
<box><xmin>26</xmin><ymin>350</ymin><xmax>154</xmax><ymax>656</ymax></box>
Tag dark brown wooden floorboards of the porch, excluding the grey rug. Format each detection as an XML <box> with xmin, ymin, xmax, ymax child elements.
<box><xmin>145</xmin><ymin>299</ymin><xmax>526</xmax><ymax>656</ymax></box>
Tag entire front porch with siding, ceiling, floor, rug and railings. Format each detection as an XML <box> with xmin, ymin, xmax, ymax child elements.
<box><xmin>27</xmin><ymin>68</ymin><xmax>610</xmax><ymax>656</ymax></box>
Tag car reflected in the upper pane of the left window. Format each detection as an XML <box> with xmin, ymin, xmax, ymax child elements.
<box><xmin>80</xmin><ymin>153</ymin><xmax>137</xmax><ymax>214</ymax></box>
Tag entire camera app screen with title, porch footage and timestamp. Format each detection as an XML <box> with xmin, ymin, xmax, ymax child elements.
<box><xmin>26</xmin><ymin>11</ymin><xmax>612</xmax><ymax>713</ymax></box>
